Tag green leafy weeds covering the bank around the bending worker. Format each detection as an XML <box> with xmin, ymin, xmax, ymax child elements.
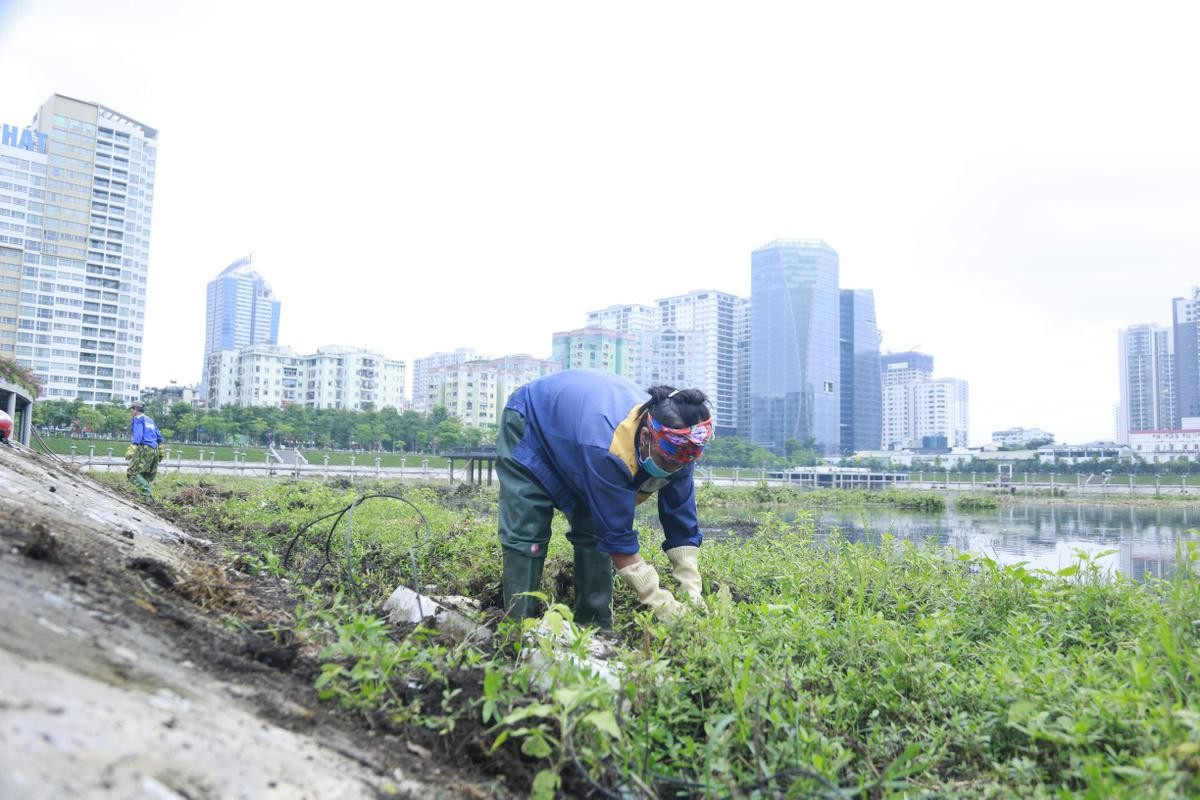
<box><xmin>88</xmin><ymin>475</ymin><xmax>1200</xmax><ymax>798</ymax></box>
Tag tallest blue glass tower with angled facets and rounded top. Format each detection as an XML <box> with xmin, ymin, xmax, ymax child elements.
<box><xmin>750</xmin><ymin>239</ymin><xmax>841</xmax><ymax>455</ymax></box>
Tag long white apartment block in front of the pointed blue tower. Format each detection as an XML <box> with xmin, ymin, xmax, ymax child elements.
<box><xmin>205</xmin><ymin>344</ymin><xmax>404</xmax><ymax>411</ymax></box>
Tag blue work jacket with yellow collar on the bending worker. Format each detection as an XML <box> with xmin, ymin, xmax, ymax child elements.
<box><xmin>505</xmin><ymin>369</ymin><xmax>703</xmax><ymax>553</ymax></box>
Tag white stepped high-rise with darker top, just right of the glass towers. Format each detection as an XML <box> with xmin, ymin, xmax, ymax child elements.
<box><xmin>880</xmin><ymin>351</ymin><xmax>970</xmax><ymax>450</ymax></box>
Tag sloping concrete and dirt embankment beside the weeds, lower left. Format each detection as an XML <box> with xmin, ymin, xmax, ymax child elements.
<box><xmin>0</xmin><ymin>446</ymin><xmax>509</xmax><ymax>800</ymax></box>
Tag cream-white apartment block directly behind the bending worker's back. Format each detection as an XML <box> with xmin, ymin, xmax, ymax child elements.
<box><xmin>426</xmin><ymin>355</ymin><xmax>562</xmax><ymax>428</ymax></box>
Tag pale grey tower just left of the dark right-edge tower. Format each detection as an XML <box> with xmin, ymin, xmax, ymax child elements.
<box><xmin>1117</xmin><ymin>325</ymin><xmax>1178</xmax><ymax>444</ymax></box>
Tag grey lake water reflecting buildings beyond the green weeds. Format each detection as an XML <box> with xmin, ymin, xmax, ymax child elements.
<box><xmin>816</xmin><ymin>500</ymin><xmax>1200</xmax><ymax>579</ymax></box>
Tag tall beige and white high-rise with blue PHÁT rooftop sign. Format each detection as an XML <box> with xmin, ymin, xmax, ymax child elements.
<box><xmin>9</xmin><ymin>95</ymin><xmax>158</xmax><ymax>404</ymax></box>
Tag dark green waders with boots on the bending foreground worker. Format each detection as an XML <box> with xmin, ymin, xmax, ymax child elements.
<box><xmin>496</xmin><ymin>409</ymin><xmax>612</xmax><ymax>628</ymax></box>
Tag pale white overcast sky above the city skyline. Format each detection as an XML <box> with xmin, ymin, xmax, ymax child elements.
<box><xmin>0</xmin><ymin>0</ymin><xmax>1200</xmax><ymax>444</ymax></box>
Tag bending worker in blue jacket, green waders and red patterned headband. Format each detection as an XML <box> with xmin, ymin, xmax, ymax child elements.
<box><xmin>496</xmin><ymin>369</ymin><xmax>713</xmax><ymax>628</ymax></box>
